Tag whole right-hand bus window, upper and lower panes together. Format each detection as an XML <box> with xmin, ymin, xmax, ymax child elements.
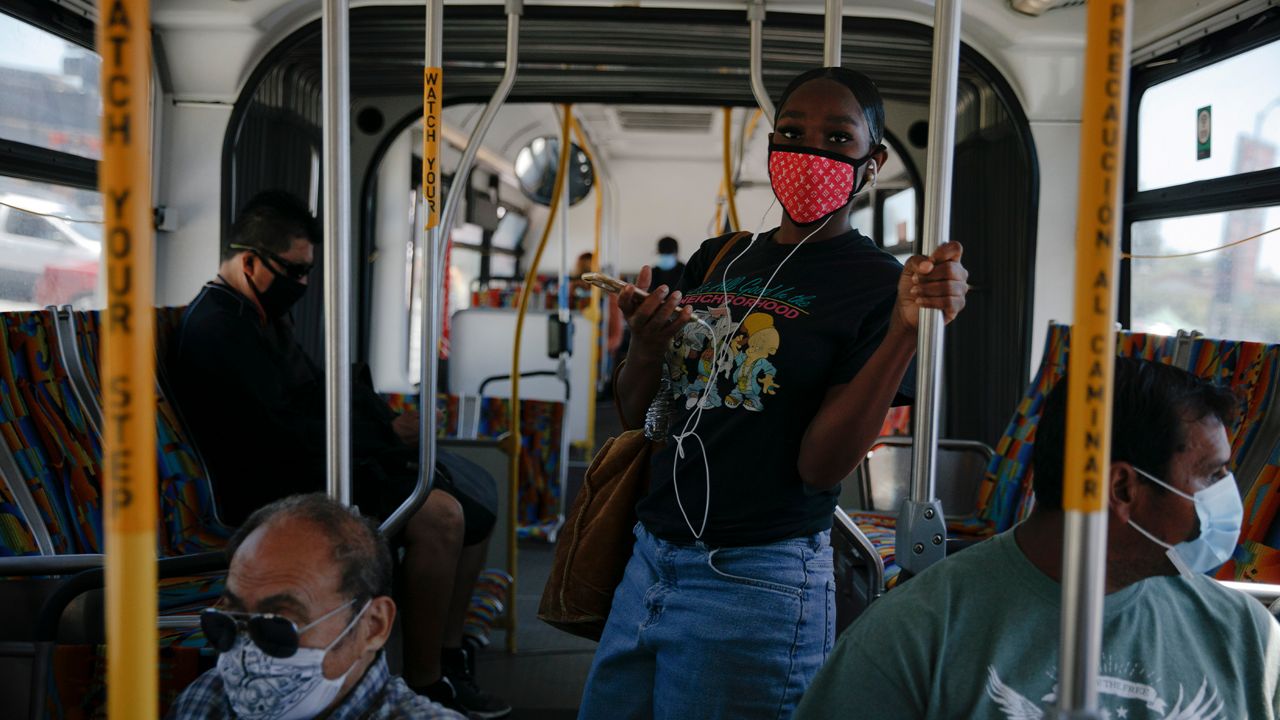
<box><xmin>1120</xmin><ymin>14</ymin><xmax>1280</xmax><ymax>342</ymax></box>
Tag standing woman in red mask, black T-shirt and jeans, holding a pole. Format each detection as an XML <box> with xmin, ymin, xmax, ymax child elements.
<box><xmin>579</xmin><ymin>68</ymin><xmax>968</xmax><ymax>720</ymax></box>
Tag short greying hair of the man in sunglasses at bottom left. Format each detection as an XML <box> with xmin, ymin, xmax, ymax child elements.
<box><xmin>227</xmin><ymin>492</ymin><xmax>392</xmax><ymax>601</ymax></box>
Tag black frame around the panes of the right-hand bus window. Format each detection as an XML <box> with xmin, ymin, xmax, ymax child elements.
<box><xmin>1117</xmin><ymin>8</ymin><xmax>1280</xmax><ymax>328</ymax></box>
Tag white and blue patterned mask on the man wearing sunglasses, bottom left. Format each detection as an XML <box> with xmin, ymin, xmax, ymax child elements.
<box><xmin>218</xmin><ymin>601</ymin><xmax>369</xmax><ymax>720</ymax></box>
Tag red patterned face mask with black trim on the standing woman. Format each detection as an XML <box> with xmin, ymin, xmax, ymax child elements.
<box><xmin>769</xmin><ymin>145</ymin><xmax>876</xmax><ymax>225</ymax></box>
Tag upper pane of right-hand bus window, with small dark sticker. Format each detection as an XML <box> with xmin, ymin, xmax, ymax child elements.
<box><xmin>1138</xmin><ymin>40</ymin><xmax>1280</xmax><ymax>191</ymax></box>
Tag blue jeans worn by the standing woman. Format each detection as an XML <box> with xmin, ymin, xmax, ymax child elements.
<box><xmin>577</xmin><ymin>524</ymin><xmax>836</xmax><ymax>720</ymax></box>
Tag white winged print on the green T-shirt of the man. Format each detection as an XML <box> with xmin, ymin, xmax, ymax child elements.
<box><xmin>986</xmin><ymin>660</ymin><xmax>1228</xmax><ymax>720</ymax></box>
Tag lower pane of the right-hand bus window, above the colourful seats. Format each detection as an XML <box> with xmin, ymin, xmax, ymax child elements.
<box><xmin>1132</xmin><ymin>206</ymin><xmax>1280</xmax><ymax>342</ymax></box>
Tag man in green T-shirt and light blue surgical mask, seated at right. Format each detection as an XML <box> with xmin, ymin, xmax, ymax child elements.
<box><xmin>796</xmin><ymin>359</ymin><xmax>1280</xmax><ymax>720</ymax></box>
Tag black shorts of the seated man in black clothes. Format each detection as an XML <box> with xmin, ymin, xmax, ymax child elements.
<box><xmin>352</xmin><ymin>443</ymin><xmax>498</xmax><ymax>546</ymax></box>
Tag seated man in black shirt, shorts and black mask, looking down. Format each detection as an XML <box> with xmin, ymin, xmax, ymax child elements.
<box><xmin>170</xmin><ymin>192</ymin><xmax>511</xmax><ymax>717</ymax></box>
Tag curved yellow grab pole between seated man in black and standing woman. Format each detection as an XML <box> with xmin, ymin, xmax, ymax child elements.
<box><xmin>507</xmin><ymin>105</ymin><xmax>573</xmax><ymax>652</ymax></box>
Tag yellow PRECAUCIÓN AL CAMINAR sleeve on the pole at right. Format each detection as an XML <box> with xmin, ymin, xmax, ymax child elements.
<box><xmin>1062</xmin><ymin>0</ymin><xmax>1129</xmax><ymax>512</ymax></box>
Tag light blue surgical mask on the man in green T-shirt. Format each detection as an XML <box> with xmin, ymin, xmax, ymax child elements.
<box><xmin>1129</xmin><ymin>468</ymin><xmax>1244</xmax><ymax>575</ymax></box>
